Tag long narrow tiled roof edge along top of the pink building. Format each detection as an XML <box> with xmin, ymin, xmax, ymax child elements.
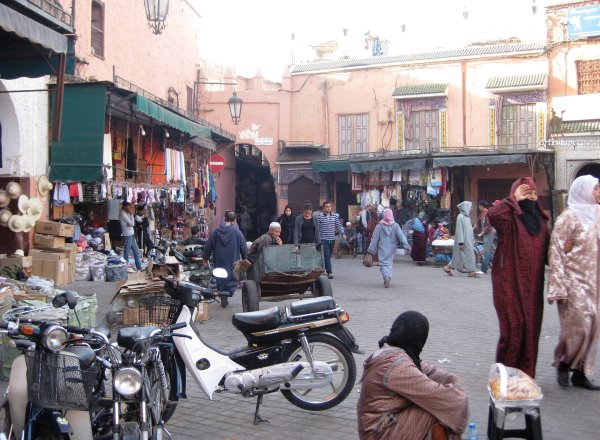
<box><xmin>291</xmin><ymin>43</ymin><xmax>546</xmax><ymax>74</ymax></box>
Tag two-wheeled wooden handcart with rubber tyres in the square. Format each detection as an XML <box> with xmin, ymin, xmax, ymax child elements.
<box><xmin>242</xmin><ymin>244</ymin><xmax>332</xmax><ymax>312</ymax></box>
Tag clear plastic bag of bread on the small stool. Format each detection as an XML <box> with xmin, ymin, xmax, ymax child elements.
<box><xmin>488</xmin><ymin>363</ymin><xmax>544</xmax><ymax>401</ymax></box>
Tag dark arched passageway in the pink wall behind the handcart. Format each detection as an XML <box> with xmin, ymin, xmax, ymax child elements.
<box><xmin>235</xmin><ymin>144</ymin><xmax>277</xmax><ymax>241</ymax></box>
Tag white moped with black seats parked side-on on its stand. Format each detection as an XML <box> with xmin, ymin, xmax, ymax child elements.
<box><xmin>152</xmin><ymin>269</ymin><xmax>362</xmax><ymax>424</ymax></box>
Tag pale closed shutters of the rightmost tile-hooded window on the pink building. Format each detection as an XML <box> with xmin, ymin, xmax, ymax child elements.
<box><xmin>500</xmin><ymin>104</ymin><xmax>535</xmax><ymax>148</ymax></box>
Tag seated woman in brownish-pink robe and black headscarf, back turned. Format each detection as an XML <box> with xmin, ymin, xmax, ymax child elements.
<box><xmin>356</xmin><ymin>311</ymin><xmax>469</xmax><ymax>440</ymax></box>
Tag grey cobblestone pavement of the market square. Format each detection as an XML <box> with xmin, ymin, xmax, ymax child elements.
<box><xmin>3</xmin><ymin>257</ymin><xmax>600</xmax><ymax>440</ymax></box>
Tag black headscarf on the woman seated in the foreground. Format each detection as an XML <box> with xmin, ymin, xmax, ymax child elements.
<box><xmin>379</xmin><ymin>311</ymin><xmax>429</xmax><ymax>370</ymax></box>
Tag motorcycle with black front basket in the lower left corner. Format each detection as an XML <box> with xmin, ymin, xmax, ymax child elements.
<box><xmin>0</xmin><ymin>292</ymin><xmax>110</xmax><ymax>440</ymax></box>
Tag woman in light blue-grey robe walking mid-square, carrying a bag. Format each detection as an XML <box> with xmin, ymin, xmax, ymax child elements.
<box><xmin>367</xmin><ymin>208</ymin><xmax>410</xmax><ymax>288</ymax></box>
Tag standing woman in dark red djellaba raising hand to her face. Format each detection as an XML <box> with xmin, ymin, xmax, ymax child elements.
<box><xmin>488</xmin><ymin>177</ymin><xmax>550</xmax><ymax>377</ymax></box>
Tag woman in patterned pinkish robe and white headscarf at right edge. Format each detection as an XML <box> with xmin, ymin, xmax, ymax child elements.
<box><xmin>548</xmin><ymin>176</ymin><xmax>600</xmax><ymax>390</ymax></box>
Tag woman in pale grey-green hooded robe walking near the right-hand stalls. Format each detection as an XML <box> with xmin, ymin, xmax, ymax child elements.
<box><xmin>444</xmin><ymin>200</ymin><xmax>479</xmax><ymax>278</ymax></box>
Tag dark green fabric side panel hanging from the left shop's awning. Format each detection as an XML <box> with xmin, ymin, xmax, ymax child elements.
<box><xmin>50</xmin><ymin>83</ymin><xmax>107</xmax><ymax>182</ymax></box>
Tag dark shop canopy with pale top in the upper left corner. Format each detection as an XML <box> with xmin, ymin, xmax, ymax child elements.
<box><xmin>0</xmin><ymin>3</ymin><xmax>74</xmax><ymax>79</ymax></box>
